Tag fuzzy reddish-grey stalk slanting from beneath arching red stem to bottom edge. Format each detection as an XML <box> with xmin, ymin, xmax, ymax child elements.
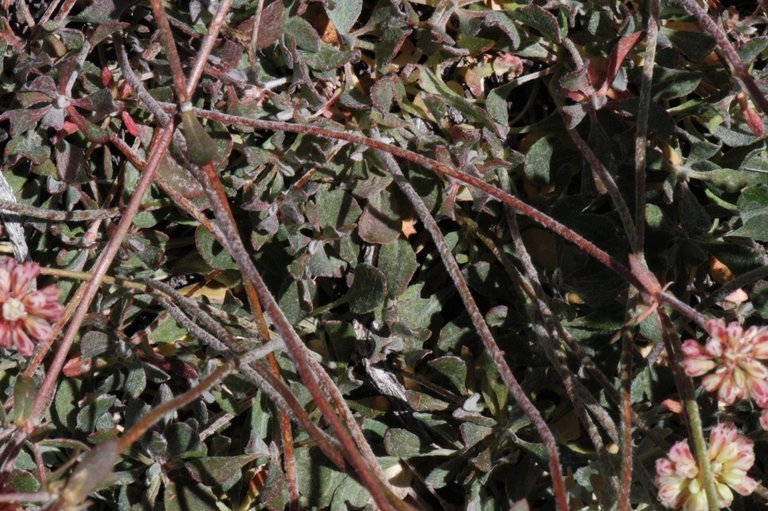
<box><xmin>378</xmin><ymin>152</ymin><xmax>568</xmax><ymax>511</ymax></box>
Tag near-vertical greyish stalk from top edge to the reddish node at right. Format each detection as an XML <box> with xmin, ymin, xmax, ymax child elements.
<box><xmin>635</xmin><ymin>0</ymin><xmax>659</xmax><ymax>247</ymax></box>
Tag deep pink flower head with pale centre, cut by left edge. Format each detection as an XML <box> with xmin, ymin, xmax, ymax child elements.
<box><xmin>0</xmin><ymin>258</ymin><xmax>64</xmax><ymax>355</ymax></box>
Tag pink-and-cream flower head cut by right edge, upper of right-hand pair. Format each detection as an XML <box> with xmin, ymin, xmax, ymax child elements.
<box><xmin>683</xmin><ymin>320</ymin><xmax>768</xmax><ymax>408</ymax></box>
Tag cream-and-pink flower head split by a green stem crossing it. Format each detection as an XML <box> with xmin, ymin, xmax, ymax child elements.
<box><xmin>656</xmin><ymin>423</ymin><xmax>757</xmax><ymax>511</ymax></box>
